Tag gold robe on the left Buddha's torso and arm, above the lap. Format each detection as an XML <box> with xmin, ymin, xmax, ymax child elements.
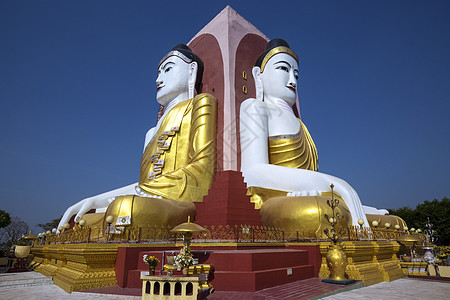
<box><xmin>139</xmin><ymin>94</ymin><xmax>217</xmax><ymax>202</ymax></box>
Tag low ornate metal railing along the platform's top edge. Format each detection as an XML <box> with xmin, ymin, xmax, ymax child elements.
<box><xmin>34</xmin><ymin>225</ymin><xmax>425</xmax><ymax>245</ymax></box>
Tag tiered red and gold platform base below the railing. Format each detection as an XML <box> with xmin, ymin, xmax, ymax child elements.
<box><xmin>32</xmin><ymin>241</ymin><xmax>404</xmax><ymax>293</ymax></box>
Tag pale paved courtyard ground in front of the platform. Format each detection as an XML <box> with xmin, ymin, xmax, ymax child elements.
<box><xmin>0</xmin><ymin>272</ymin><xmax>450</xmax><ymax>300</ymax></box>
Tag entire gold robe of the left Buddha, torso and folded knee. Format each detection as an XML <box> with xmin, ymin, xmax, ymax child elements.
<box><xmin>105</xmin><ymin>94</ymin><xmax>217</xmax><ymax>227</ymax></box>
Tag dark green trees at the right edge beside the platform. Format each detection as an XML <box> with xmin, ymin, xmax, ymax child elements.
<box><xmin>388</xmin><ymin>198</ymin><xmax>450</xmax><ymax>245</ymax></box>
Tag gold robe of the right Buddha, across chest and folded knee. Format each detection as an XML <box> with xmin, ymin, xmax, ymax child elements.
<box><xmin>253</xmin><ymin>120</ymin><xmax>352</xmax><ymax>239</ymax></box>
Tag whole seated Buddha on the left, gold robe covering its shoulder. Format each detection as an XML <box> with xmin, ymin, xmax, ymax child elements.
<box><xmin>60</xmin><ymin>44</ymin><xmax>217</xmax><ymax>227</ymax></box>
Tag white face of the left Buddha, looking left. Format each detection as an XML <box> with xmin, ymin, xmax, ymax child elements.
<box><xmin>156</xmin><ymin>56</ymin><xmax>190</xmax><ymax>106</ymax></box>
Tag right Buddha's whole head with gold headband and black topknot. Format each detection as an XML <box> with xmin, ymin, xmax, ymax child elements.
<box><xmin>252</xmin><ymin>39</ymin><xmax>298</xmax><ymax>106</ymax></box>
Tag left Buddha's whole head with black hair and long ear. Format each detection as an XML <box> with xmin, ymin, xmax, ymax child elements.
<box><xmin>156</xmin><ymin>44</ymin><xmax>203</xmax><ymax>106</ymax></box>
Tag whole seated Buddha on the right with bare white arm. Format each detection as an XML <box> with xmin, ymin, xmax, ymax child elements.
<box><xmin>240</xmin><ymin>39</ymin><xmax>384</xmax><ymax>237</ymax></box>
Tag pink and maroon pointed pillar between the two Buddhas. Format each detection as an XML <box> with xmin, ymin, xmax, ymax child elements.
<box><xmin>188</xmin><ymin>6</ymin><xmax>269</xmax><ymax>225</ymax></box>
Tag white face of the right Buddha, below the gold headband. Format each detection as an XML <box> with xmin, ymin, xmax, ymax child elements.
<box><xmin>261</xmin><ymin>53</ymin><xmax>298</xmax><ymax>106</ymax></box>
